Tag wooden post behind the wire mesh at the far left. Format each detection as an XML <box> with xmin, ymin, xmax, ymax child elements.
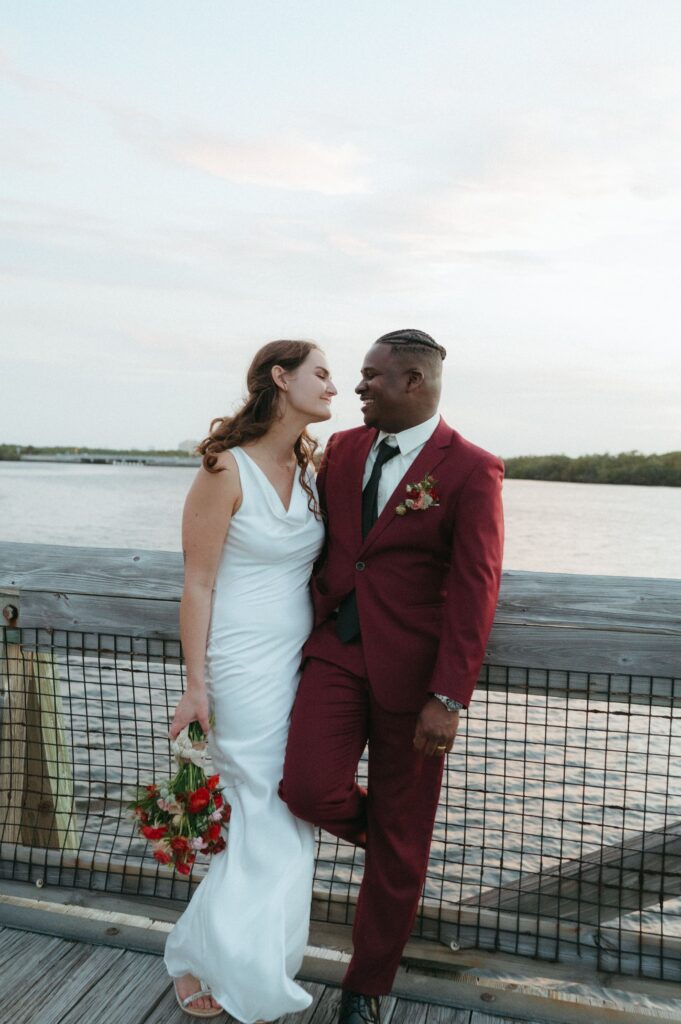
<box><xmin>0</xmin><ymin>604</ymin><xmax>79</xmax><ymax>850</ymax></box>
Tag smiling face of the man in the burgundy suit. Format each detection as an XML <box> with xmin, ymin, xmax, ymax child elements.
<box><xmin>354</xmin><ymin>345</ymin><xmax>411</xmax><ymax>433</ymax></box>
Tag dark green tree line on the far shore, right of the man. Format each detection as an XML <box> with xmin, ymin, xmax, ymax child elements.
<box><xmin>505</xmin><ymin>452</ymin><xmax>681</xmax><ymax>487</ymax></box>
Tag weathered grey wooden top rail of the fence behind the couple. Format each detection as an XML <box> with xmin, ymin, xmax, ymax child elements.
<box><xmin>5</xmin><ymin>544</ymin><xmax>681</xmax><ymax>677</ymax></box>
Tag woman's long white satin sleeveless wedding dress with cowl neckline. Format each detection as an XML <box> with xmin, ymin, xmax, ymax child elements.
<box><xmin>165</xmin><ymin>447</ymin><xmax>324</xmax><ymax>1024</ymax></box>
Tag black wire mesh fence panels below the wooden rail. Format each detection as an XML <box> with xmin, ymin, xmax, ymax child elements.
<box><xmin>0</xmin><ymin>629</ymin><xmax>681</xmax><ymax>980</ymax></box>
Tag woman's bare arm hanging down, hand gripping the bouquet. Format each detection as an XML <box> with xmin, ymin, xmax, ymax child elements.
<box><xmin>168</xmin><ymin>452</ymin><xmax>241</xmax><ymax>739</ymax></box>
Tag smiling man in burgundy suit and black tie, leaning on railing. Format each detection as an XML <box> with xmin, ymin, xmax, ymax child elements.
<box><xmin>282</xmin><ymin>330</ymin><xmax>503</xmax><ymax>1024</ymax></box>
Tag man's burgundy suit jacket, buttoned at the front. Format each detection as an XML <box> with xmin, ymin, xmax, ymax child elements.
<box><xmin>304</xmin><ymin>419</ymin><xmax>504</xmax><ymax>712</ymax></box>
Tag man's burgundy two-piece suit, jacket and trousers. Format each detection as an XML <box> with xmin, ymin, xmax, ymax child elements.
<box><xmin>282</xmin><ymin>420</ymin><xmax>503</xmax><ymax>995</ymax></box>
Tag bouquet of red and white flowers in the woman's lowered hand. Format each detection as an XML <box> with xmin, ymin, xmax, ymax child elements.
<box><xmin>128</xmin><ymin>722</ymin><xmax>231</xmax><ymax>874</ymax></box>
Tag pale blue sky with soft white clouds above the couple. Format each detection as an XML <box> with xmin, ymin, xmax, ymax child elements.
<box><xmin>0</xmin><ymin>0</ymin><xmax>681</xmax><ymax>457</ymax></box>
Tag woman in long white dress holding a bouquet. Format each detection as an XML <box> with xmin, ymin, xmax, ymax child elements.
<box><xmin>165</xmin><ymin>341</ymin><xmax>336</xmax><ymax>1024</ymax></box>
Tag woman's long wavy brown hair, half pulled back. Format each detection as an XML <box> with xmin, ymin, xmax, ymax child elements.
<box><xmin>197</xmin><ymin>341</ymin><xmax>321</xmax><ymax>518</ymax></box>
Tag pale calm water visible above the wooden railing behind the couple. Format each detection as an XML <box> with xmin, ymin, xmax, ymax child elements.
<box><xmin>0</xmin><ymin>462</ymin><xmax>681</xmax><ymax>579</ymax></box>
